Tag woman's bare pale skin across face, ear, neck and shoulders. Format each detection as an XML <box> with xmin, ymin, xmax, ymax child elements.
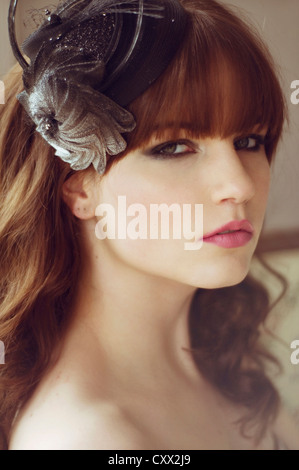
<box><xmin>10</xmin><ymin>130</ymin><xmax>299</xmax><ymax>449</ymax></box>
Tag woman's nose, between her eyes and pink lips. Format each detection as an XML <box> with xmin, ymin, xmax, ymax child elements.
<box><xmin>209</xmin><ymin>140</ymin><xmax>255</xmax><ymax>204</ymax></box>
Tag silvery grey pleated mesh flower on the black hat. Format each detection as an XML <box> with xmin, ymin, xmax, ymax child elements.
<box><xmin>18</xmin><ymin>49</ymin><xmax>135</xmax><ymax>174</ymax></box>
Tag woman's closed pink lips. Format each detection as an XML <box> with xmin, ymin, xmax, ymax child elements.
<box><xmin>203</xmin><ymin>220</ymin><xmax>254</xmax><ymax>248</ymax></box>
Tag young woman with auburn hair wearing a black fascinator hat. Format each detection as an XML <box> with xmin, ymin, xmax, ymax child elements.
<box><xmin>0</xmin><ymin>0</ymin><xmax>299</xmax><ymax>450</ymax></box>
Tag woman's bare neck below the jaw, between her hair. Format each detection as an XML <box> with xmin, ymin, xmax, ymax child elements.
<box><xmin>69</xmin><ymin>237</ymin><xmax>198</xmax><ymax>384</ymax></box>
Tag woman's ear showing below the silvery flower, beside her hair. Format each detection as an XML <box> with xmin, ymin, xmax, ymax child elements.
<box><xmin>62</xmin><ymin>172</ymin><xmax>96</xmax><ymax>220</ymax></box>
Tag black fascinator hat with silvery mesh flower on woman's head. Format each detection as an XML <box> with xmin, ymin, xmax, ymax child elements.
<box><xmin>8</xmin><ymin>0</ymin><xmax>187</xmax><ymax>174</ymax></box>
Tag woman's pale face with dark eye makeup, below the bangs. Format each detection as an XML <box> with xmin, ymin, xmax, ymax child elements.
<box><xmin>95</xmin><ymin>130</ymin><xmax>270</xmax><ymax>288</ymax></box>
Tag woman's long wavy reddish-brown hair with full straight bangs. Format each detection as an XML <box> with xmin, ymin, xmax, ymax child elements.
<box><xmin>0</xmin><ymin>0</ymin><xmax>286</xmax><ymax>449</ymax></box>
